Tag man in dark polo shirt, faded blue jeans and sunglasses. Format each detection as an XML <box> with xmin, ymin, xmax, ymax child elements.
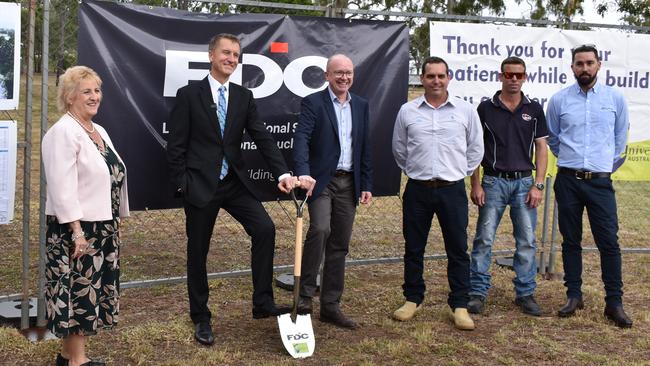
<box><xmin>467</xmin><ymin>57</ymin><xmax>548</xmax><ymax>316</ymax></box>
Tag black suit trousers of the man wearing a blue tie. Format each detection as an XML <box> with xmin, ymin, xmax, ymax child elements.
<box><xmin>184</xmin><ymin>173</ymin><xmax>275</xmax><ymax>324</ymax></box>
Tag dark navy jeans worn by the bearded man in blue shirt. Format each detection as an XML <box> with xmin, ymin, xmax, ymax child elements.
<box><xmin>554</xmin><ymin>174</ymin><xmax>623</xmax><ymax>306</ymax></box>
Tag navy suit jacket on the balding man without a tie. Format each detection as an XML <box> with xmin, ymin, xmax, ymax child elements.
<box><xmin>293</xmin><ymin>88</ymin><xmax>372</xmax><ymax>203</ymax></box>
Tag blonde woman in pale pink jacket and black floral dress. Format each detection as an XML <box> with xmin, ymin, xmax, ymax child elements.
<box><xmin>42</xmin><ymin>66</ymin><xmax>129</xmax><ymax>366</ymax></box>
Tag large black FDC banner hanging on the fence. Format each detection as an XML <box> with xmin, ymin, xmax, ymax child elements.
<box><xmin>78</xmin><ymin>1</ymin><xmax>408</xmax><ymax>210</ymax></box>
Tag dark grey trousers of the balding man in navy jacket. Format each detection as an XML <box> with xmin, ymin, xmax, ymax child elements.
<box><xmin>300</xmin><ymin>174</ymin><xmax>357</xmax><ymax>311</ymax></box>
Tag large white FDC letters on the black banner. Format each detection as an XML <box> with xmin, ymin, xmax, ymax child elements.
<box><xmin>163</xmin><ymin>50</ymin><xmax>327</xmax><ymax>99</ymax></box>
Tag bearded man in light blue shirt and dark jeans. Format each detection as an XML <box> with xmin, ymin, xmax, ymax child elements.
<box><xmin>546</xmin><ymin>45</ymin><xmax>632</xmax><ymax>328</ymax></box>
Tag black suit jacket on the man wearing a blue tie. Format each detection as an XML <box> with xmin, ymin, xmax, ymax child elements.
<box><xmin>167</xmin><ymin>77</ymin><xmax>289</xmax><ymax>207</ymax></box>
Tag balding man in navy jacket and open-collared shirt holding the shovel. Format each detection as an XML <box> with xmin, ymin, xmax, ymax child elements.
<box><xmin>293</xmin><ymin>54</ymin><xmax>372</xmax><ymax>329</ymax></box>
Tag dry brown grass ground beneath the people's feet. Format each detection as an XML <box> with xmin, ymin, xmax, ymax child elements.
<box><xmin>0</xmin><ymin>254</ymin><xmax>650</xmax><ymax>365</ymax></box>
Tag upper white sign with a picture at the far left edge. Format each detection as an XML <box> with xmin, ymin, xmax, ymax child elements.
<box><xmin>0</xmin><ymin>2</ymin><xmax>20</xmax><ymax>110</ymax></box>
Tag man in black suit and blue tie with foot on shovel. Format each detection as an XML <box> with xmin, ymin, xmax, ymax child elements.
<box><xmin>167</xmin><ymin>34</ymin><xmax>296</xmax><ymax>345</ymax></box>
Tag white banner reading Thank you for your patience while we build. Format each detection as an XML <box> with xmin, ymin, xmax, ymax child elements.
<box><xmin>430</xmin><ymin>22</ymin><xmax>650</xmax><ymax>180</ymax></box>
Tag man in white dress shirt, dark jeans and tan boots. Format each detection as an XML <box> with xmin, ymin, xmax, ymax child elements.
<box><xmin>393</xmin><ymin>57</ymin><xmax>483</xmax><ymax>330</ymax></box>
